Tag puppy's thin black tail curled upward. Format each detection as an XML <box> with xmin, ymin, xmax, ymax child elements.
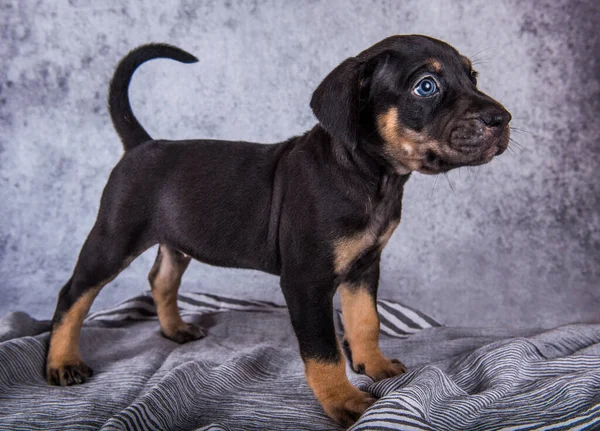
<box><xmin>108</xmin><ymin>43</ymin><xmax>198</xmax><ymax>151</ymax></box>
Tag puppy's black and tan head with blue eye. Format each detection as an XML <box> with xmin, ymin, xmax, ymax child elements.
<box><xmin>311</xmin><ymin>35</ymin><xmax>511</xmax><ymax>174</ymax></box>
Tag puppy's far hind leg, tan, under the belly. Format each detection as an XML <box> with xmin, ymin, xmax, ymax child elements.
<box><xmin>148</xmin><ymin>244</ymin><xmax>206</xmax><ymax>344</ymax></box>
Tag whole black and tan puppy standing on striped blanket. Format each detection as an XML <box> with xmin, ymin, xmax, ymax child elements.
<box><xmin>47</xmin><ymin>36</ymin><xmax>511</xmax><ymax>425</ymax></box>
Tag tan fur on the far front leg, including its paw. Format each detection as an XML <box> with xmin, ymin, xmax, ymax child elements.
<box><xmin>339</xmin><ymin>284</ymin><xmax>405</xmax><ymax>380</ymax></box>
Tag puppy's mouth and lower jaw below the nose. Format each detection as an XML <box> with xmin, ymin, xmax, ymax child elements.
<box><xmin>418</xmin><ymin>125</ymin><xmax>510</xmax><ymax>175</ymax></box>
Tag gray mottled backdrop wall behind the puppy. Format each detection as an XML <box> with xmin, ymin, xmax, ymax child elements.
<box><xmin>0</xmin><ymin>0</ymin><xmax>600</xmax><ymax>327</ymax></box>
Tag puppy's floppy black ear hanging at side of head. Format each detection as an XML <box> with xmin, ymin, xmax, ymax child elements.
<box><xmin>310</xmin><ymin>57</ymin><xmax>363</xmax><ymax>147</ymax></box>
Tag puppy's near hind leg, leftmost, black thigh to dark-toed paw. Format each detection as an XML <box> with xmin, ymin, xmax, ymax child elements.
<box><xmin>46</xmin><ymin>222</ymin><xmax>147</xmax><ymax>386</ymax></box>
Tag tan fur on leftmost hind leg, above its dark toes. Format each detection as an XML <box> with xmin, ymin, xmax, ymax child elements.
<box><xmin>47</xmin><ymin>286</ymin><xmax>102</xmax><ymax>369</ymax></box>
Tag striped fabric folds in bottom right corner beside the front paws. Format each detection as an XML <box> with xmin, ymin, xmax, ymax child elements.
<box><xmin>352</xmin><ymin>325</ymin><xmax>600</xmax><ymax>431</ymax></box>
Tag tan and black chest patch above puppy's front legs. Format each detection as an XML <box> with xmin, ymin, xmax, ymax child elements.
<box><xmin>333</xmin><ymin>193</ymin><xmax>402</xmax><ymax>277</ymax></box>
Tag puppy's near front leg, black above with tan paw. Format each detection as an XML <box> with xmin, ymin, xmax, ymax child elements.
<box><xmin>281</xmin><ymin>271</ymin><xmax>375</xmax><ymax>427</ymax></box>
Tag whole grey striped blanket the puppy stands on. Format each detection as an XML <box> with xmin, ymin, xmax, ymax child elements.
<box><xmin>0</xmin><ymin>293</ymin><xmax>600</xmax><ymax>431</ymax></box>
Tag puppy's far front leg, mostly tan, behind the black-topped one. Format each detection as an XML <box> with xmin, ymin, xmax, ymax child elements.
<box><xmin>339</xmin><ymin>257</ymin><xmax>406</xmax><ymax>381</ymax></box>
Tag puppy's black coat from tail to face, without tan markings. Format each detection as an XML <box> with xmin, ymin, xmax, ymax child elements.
<box><xmin>49</xmin><ymin>36</ymin><xmax>510</xmax><ymax>428</ymax></box>
